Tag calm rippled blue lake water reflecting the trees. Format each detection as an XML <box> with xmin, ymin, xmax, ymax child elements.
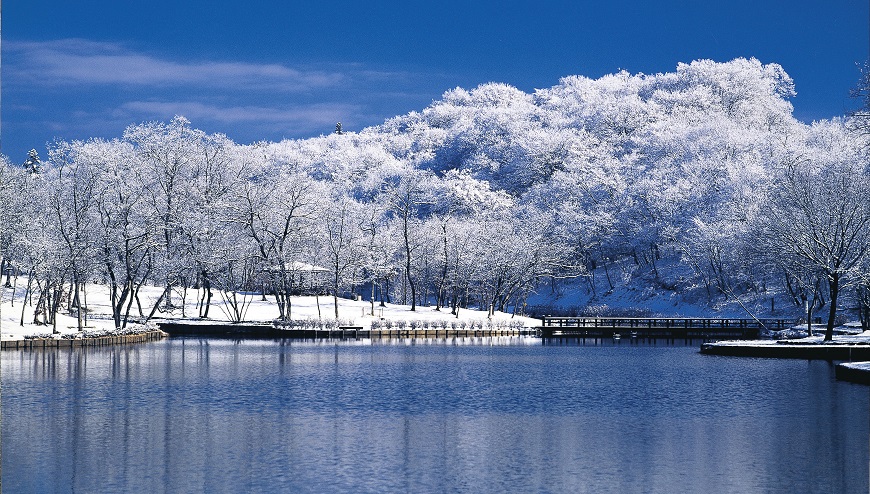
<box><xmin>2</xmin><ymin>338</ymin><xmax>870</xmax><ymax>493</ymax></box>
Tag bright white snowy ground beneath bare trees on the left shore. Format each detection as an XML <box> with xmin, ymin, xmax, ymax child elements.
<box><xmin>0</xmin><ymin>279</ymin><xmax>541</xmax><ymax>340</ymax></box>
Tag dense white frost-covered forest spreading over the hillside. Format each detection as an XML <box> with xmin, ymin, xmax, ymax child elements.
<box><xmin>0</xmin><ymin>59</ymin><xmax>870</xmax><ymax>338</ymax></box>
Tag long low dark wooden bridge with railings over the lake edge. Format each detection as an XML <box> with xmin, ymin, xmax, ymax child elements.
<box><xmin>540</xmin><ymin>316</ymin><xmax>794</xmax><ymax>339</ymax></box>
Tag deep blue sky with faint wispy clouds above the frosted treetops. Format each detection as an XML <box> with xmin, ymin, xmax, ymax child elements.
<box><xmin>2</xmin><ymin>0</ymin><xmax>870</xmax><ymax>162</ymax></box>
